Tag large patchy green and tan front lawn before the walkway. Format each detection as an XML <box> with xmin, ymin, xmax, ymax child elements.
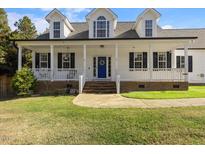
<box><xmin>0</xmin><ymin>96</ymin><xmax>205</xmax><ymax>144</ymax></box>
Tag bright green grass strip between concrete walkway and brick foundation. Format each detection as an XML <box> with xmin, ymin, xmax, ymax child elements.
<box><xmin>122</xmin><ymin>86</ymin><xmax>205</xmax><ymax>99</ymax></box>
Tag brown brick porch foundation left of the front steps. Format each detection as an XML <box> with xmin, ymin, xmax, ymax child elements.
<box><xmin>35</xmin><ymin>81</ymin><xmax>78</xmax><ymax>94</ymax></box>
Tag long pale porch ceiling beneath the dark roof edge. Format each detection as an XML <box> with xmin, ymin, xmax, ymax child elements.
<box><xmin>16</xmin><ymin>39</ymin><xmax>192</xmax><ymax>51</ymax></box>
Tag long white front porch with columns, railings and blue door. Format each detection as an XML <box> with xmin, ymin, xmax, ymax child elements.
<box><xmin>15</xmin><ymin>38</ymin><xmax>194</xmax><ymax>93</ymax></box>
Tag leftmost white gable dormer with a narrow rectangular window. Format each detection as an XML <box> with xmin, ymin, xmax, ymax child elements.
<box><xmin>45</xmin><ymin>9</ymin><xmax>74</xmax><ymax>39</ymax></box>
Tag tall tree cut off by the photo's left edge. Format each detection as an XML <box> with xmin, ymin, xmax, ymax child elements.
<box><xmin>0</xmin><ymin>8</ymin><xmax>10</xmax><ymax>64</ymax></box>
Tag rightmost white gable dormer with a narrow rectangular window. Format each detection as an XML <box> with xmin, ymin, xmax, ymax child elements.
<box><xmin>133</xmin><ymin>9</ymin><xmax>161</xmax><ymax>37</ymax></box>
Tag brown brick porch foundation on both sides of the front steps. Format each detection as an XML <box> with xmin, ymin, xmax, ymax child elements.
<box><xmin>35</xmin><ymin>81</ymin><xmax>189</xmax><ymax>94</ymax></box>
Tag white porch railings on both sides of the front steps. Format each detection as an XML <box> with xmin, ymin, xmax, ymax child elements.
<box><xmin>33</xmin><ymin>68</ymin><xmax>186</xmax><ymax>84</ymax></box>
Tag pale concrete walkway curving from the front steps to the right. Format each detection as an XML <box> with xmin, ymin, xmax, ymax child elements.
<box><xmin>73</xmin><ymin>94</ymin><xmax>205</xmax><ymax>108</ymax></box>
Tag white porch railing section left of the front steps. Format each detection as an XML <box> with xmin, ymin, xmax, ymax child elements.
<box><xmin>33</xmin><ymin>68</ymin><xmax>78</xmax><ymax>80</ymax></box>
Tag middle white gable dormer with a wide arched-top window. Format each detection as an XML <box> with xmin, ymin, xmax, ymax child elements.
<box><xmin>86</xmin><ymin>8</ymin><xmax>117</xmax><ymax>38</ymax></box>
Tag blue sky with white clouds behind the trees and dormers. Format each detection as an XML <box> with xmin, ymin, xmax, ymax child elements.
<box><xmin>5</xmin><ymin>8</ymin><xmax>205</xmax><ymax>33</ymax></box>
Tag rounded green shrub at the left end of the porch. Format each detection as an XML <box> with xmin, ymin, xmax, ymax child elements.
<box><xmin>12</xmin><ymin>67</ymin><xmax>36</xmax><ymax>95</ymax></box>
